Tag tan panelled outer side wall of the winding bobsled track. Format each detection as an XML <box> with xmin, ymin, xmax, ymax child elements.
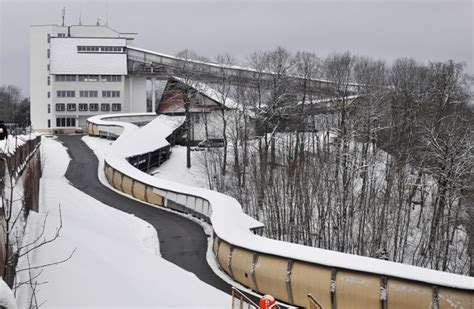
<box><xmin>87</xmin><ymin>116</ymin><xmax>474</xmax><ymax>309</ymax></box>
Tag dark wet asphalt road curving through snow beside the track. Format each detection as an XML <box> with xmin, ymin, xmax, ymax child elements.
<box><xmin>58</xmin><ymin>135</ymin><xmax>231</xmax><ymax>294</ymax></box>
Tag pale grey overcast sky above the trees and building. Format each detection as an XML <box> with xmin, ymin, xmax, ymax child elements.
<box><xmin>0</xmin><ymin>0</ymin><xmax>474</xmax><ymax>95</ymax></box>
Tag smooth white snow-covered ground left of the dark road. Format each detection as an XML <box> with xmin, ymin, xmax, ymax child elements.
<box><xmin>18</xmin><ymin>139</ymin><xmax>231</xmax><ymax>308</ymax></box>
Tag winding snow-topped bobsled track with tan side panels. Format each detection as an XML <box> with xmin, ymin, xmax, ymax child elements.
<box><xmin>86</xmin><ymin>113</ymin><xmax>474</xmax><ymax>309</ymax></box>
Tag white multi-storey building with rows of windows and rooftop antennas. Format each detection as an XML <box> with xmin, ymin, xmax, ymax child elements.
<box><xmin>30</xmin><ymin>25</ymin><xmax>147</xmax><ymax>131</ymax></box>
